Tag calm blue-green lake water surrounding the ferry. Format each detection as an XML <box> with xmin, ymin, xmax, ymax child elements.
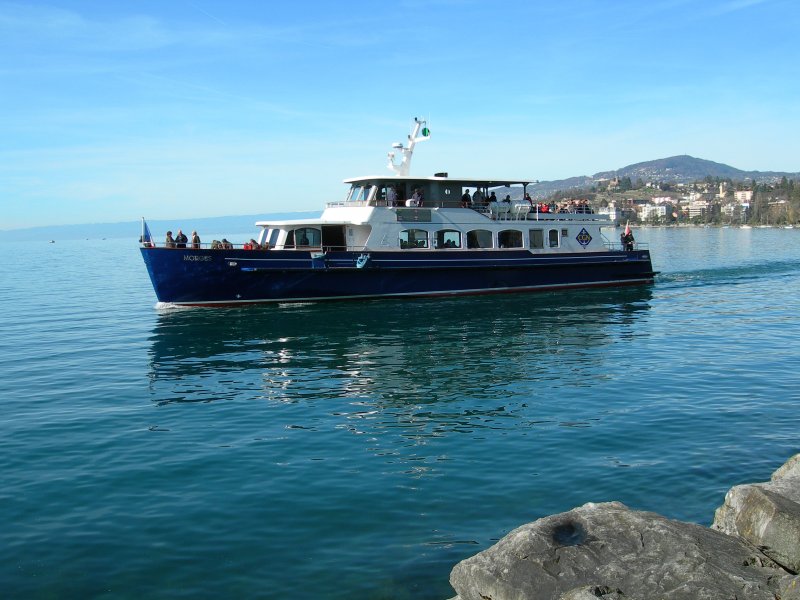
<box><xmin>0</xmin><ymin>228</ymin><xmax>800</xmax><ymax>600</ymax></box>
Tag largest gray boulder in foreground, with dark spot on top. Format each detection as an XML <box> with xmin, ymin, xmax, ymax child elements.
<box><xmin>450</xmin><ymin>502</ymin><xmax>792</xmax><ymax>600</ymax></box>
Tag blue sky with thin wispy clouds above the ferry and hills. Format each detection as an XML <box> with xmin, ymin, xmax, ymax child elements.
<box><xmin>0</xmin><ymin>0</ymin><xmax>800</xmax><ymax>229</ymax></box>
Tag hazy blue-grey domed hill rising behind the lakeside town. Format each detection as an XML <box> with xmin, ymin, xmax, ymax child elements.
<box><xmin>532</xmin><ymin>154</ymin><xmax>800</xmax><ymax>196</ymax></box>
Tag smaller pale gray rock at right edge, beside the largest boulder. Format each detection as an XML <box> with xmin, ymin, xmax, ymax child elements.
<box><xmin>711</xmin><ymin>454</ymin><xmax>800</xmax><ymax>573</ymax></box>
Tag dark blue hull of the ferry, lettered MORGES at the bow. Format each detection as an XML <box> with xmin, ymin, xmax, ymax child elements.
<box><xmin>141</xmin><ymin>248</ymin><xmax>655</xmax><ymax>305</ymax></box>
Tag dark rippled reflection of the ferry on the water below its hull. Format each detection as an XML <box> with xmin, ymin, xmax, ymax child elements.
<box><xmin>150</xmin><ymin>287</ymin><xmax>651</xmax><ymax>408</ymax></box>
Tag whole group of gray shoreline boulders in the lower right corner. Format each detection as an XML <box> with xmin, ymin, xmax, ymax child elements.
<box><xmin>450</xmin><ymin>454</ymin><xmax>800</xmax><ymax>600</ymax></box>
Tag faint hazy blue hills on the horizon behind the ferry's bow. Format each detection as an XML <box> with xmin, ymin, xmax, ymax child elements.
<box><xmin>0</xmin><ymin>212</ymin><xmax>319</xmax><ymax>242</ymax></box>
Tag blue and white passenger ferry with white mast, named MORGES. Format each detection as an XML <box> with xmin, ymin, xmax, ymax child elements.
<box><xmin>141</xmin><ymin>119</ymin><xmax>655</xmax><ymax>306</ymax></box>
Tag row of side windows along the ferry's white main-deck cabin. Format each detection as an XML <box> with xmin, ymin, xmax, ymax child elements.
<box><xmin>400</xmin><ymin>229</ymin><xmax>567</xmax><ymax>250</ymax></box>
